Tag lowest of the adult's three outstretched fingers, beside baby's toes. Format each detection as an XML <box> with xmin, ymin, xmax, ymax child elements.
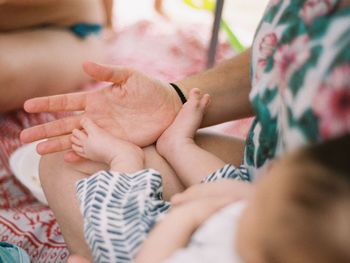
<box><xmin>36</xmin><ymin>135</ymin><xmax>72</xmax><ymax>155</ymax></box>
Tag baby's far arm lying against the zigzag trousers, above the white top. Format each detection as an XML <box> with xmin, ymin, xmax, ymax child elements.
<box><xmin>171</xmin><ymin>179</ymin><xmax>254</xmax><ymax>207</ymax></box>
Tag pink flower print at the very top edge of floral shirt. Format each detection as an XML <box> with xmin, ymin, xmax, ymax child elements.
<box><xmin>300</xmin><ymin>0</ymin><xmax>337</xmax><ymax>24</ymax></box>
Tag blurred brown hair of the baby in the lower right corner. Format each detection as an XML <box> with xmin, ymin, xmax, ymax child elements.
<box><xmin>264</xmin><ymin>135</ymin><xmax>350</xmax><ymax>263</ymax></box>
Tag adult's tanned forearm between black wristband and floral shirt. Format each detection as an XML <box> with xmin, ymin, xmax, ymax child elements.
<box><xmin>177</xmin><ymin>49</ymin><xmax>253</xmax><ymax>127</ymax></box>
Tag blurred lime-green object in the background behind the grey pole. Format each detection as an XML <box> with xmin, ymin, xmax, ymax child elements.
<box><xmin>183</xmin><ymin>0</ymin><xmax>244</xmax><ymax>53</ymax></box>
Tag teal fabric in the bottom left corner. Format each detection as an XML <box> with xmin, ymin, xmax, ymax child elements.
<box><xmin>0</xmin><ymin>242</ymin><xmax>30</xmax><ymax>263</ymax></box>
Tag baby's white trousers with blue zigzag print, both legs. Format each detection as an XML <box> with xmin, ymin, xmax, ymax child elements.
<box><xmin>77</xmin><ymin>164</ymin><xmax>249</xmax><ymax>263</ymax></box>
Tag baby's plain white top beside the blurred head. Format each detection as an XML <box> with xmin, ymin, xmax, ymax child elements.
<box><xmin>164</xmin><ymin>201</ymin><xmax>246</xmax><ymax>263</ymax></box>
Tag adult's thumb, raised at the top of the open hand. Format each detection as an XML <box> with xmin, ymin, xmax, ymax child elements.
<box><xmin>83</xmin><ymin>62</ymin><xmax>133</xmax><ymax>84</ymax></box>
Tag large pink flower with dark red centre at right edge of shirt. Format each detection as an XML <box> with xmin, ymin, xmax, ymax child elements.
<box><xmin>313</xmin><ymin>64</ymin><xmax>350</xmax><ymax>139</ymax></box>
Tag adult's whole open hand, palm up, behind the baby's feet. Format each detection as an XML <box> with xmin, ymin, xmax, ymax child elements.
<box><xmin>21</xmin><ymin>62</ymin><xmax>181</xmax><ymax>161</ymax></box>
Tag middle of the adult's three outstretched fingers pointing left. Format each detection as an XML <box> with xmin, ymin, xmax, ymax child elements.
<box><xmin>20</xmin><ymin>115</ymin><xmax>81</xmax><ymax>143</ymax></box>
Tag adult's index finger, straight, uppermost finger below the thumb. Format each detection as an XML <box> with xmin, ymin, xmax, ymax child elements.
<box><xmin>23</xmin><ymin>92</ymin><xmax>89</xmax><ymax>113</ymax></box>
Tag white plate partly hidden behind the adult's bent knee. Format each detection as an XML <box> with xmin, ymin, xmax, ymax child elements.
<box><xmin>10</xmin><ymin>142</ymin><xmax>47</xmax><ymax>205</ymax></box>
